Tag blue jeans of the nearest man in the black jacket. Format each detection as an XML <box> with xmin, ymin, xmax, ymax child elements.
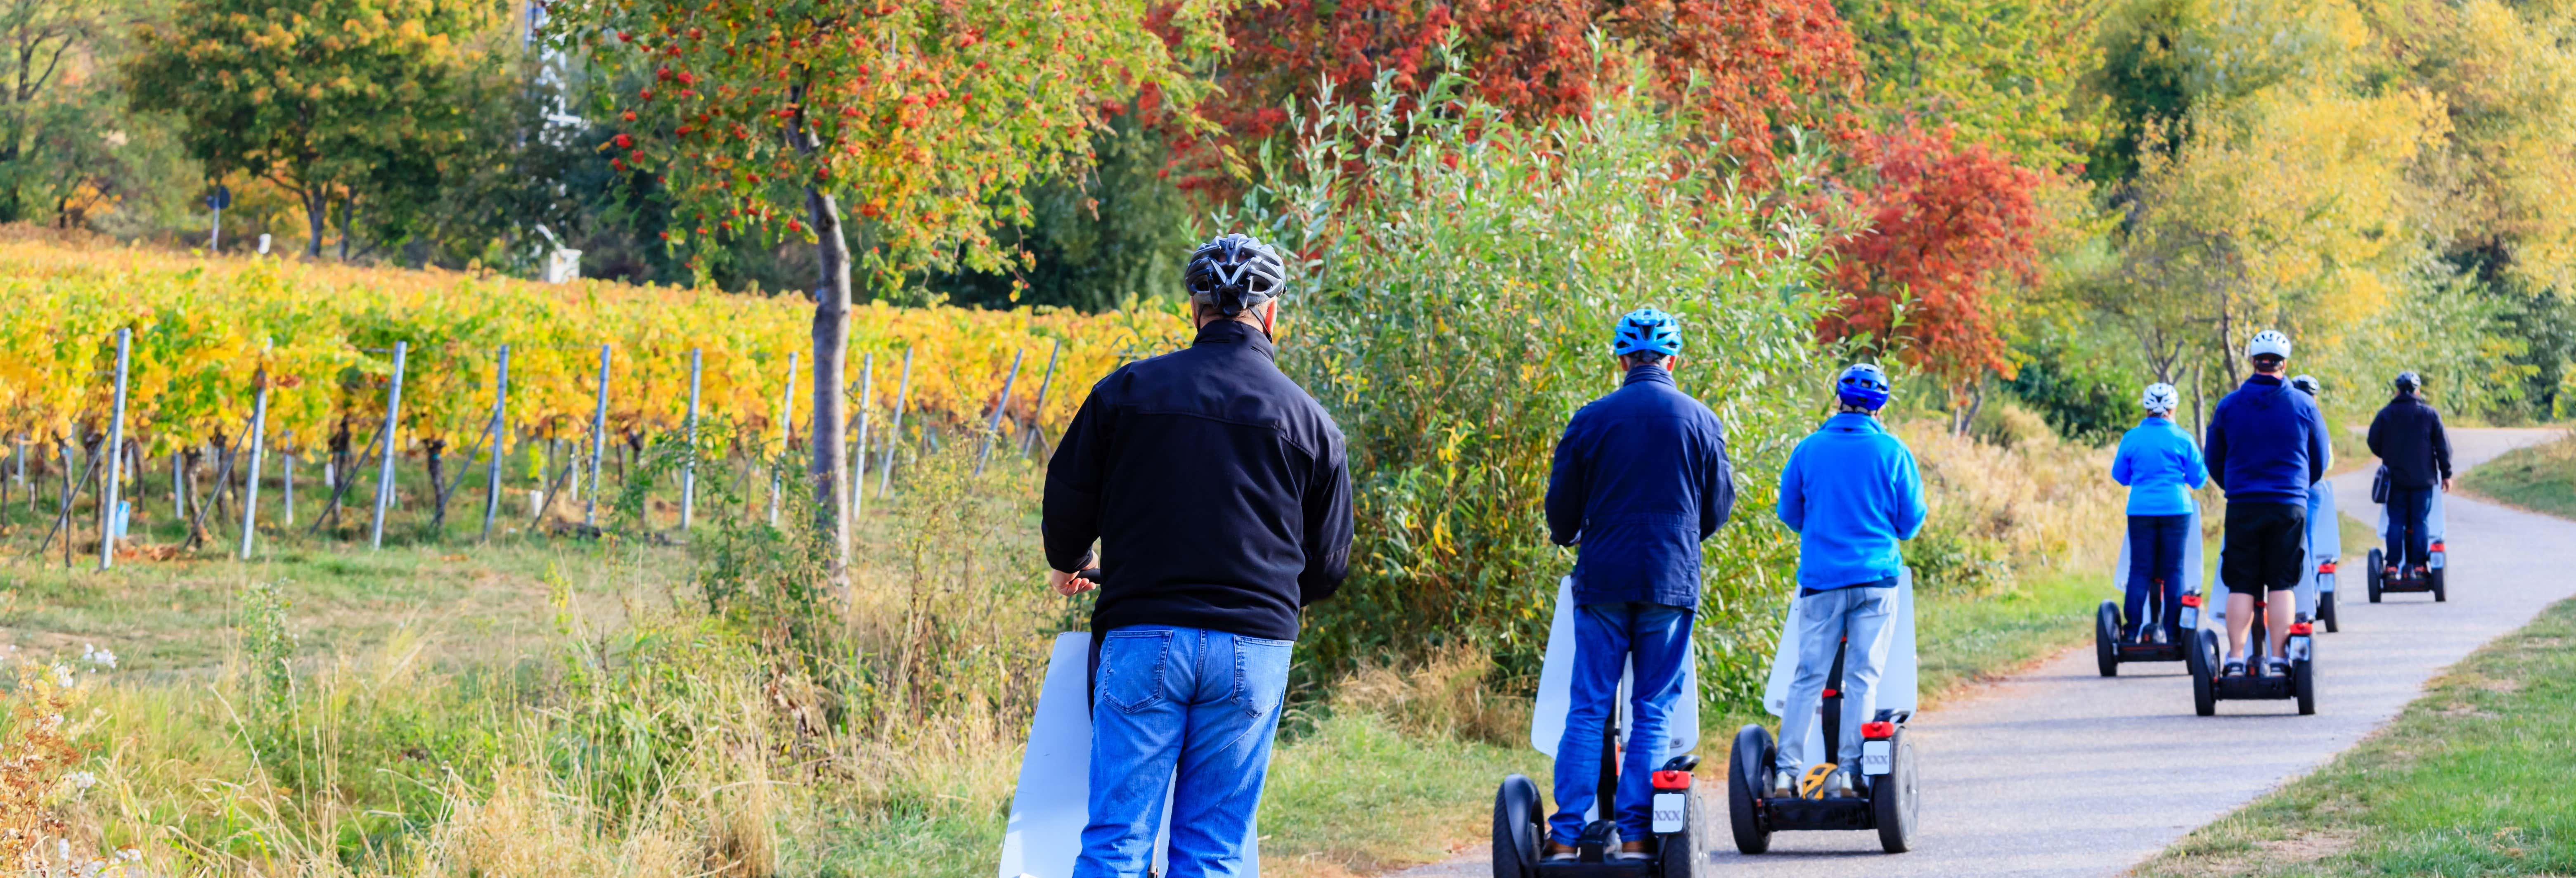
<box><xmin>1074</xmin><ymin>626</ymin><xmax>1296</xmax><ymax>878</ymax></box>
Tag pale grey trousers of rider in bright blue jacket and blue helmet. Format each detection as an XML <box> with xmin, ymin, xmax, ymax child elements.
<box><xmin>1775</xmin><ymin>579</ymin><xmax>1896</xmax><ymax>775</ymax></box>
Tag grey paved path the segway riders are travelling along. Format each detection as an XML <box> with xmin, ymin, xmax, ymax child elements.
<box><xmin>1399</xmin><ymin>430</ymin><xmax>2576</xmax><ymax>878</ymax></box>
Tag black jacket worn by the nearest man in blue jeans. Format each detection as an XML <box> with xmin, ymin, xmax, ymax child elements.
<box><xmin>1041</xmin><ymin>322</ymin><xmax>1350</xmax><ymax>641</ymax></box>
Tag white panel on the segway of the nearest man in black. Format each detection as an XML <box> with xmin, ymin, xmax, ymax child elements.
<box><xmin>997</xmin><ymin>631</ymin><xmax>1262</xmax><ymax>878</ymax></box>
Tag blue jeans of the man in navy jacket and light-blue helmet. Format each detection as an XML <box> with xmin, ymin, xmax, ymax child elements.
<box><xmin>1548</xmin><ymin>603</ymin><xmax>1695</xmax><ymax>845</ymax></box>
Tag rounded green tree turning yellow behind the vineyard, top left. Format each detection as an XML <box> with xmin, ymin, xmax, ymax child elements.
<box><xmin>126</xmin><ymin>0</ymin><xmax>513</xmax><ymax>258</ymax></box>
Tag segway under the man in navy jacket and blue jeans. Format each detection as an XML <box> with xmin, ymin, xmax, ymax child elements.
<box><xmin>1494</xmin><ymin>577</ymin><xmax>1708</xmax><ymax>878</ymax></box>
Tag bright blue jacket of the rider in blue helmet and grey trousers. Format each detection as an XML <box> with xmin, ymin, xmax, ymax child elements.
<box><xmin>1780</xmin><ymin>414</ymin><xmax>1924</xmax><ymax>592</ymax></box>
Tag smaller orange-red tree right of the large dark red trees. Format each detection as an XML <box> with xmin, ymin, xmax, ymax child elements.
<box><xmin>1816</xmin><ymin>123</ymin><xmax>2040</xmax><ymax>389</ymax></box>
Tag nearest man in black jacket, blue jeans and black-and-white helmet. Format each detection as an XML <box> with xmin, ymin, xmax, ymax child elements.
<box><xmin>1041</xmin><ymin>234</ymin><xmax>1350</xmax><ymax>878</ymax></box>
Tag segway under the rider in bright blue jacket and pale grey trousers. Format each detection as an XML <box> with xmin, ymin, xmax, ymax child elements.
<box><xmin>1726</xmin><ymin>569</ymin><xmax>1922</xmax><ymax>855</ymax></box>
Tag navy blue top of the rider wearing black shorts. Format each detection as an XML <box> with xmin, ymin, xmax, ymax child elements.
<box><xmin>2202</xmin><ymin>376</ymin><xmax>2334</xmax><ymax>507</ymax></box>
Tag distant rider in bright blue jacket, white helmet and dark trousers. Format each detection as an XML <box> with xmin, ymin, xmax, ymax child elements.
<box><xmin>2110</xmin><ymin>381</ymin><xmax>2210</xmax><ymax>644</ymax></box>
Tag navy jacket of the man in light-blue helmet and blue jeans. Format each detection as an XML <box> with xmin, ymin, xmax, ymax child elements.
<box><xmin>1548</xmin><ymin>366</ymin><xmax>1736</xmax><ymax>608</ymax></box>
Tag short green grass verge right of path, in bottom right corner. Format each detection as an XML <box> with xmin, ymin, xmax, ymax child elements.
<box><xmin>2138</xmin><ymin>600</ymin><xmax>2576</xmax><ymax>878</ymax></box>
